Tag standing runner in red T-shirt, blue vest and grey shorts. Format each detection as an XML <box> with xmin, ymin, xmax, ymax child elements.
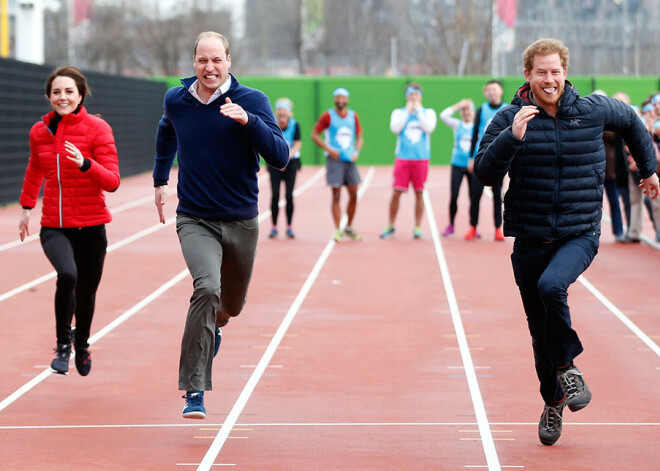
<box><xmin>312</xmin><ymin>87</ymin><xmax>363</xmax><ymax>242</ymax></box>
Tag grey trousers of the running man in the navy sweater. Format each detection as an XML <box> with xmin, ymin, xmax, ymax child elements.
<box><xmin>176</xmin><ymin>213</ymin><xmax>259</xmax><ymax>391</ymax></box>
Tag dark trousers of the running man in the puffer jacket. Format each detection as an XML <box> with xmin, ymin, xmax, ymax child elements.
<box><xmin>511</xmin><ymin>232</ymin><xmax>600</xmax><ymax>403</ymax></box>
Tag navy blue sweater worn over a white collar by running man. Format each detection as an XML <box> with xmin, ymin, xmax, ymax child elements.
<box><xmin>153</xmin><ymin>76</ymin><xmax>289</xmax><ymax>221</ymax></box>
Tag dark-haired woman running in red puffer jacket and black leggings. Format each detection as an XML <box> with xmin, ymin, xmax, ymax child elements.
<box><xmin>19</xmin><ymin>67</ymin><xmax>119</xmax><ymax>376</ymax></box>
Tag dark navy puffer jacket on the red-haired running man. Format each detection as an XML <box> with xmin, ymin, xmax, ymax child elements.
<box><xmin>474</xmin><ymin>81</ymin><xmax>657</xmax><ymax>241</ymax></box>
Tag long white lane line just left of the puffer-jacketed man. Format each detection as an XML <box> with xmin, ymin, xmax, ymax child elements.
<box><xmin>424</xmin><ymin>191</ymin><xmax>501</xmax><ymax>471</ymax></box>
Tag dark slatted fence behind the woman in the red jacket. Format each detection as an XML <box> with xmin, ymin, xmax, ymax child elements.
<box><xmin>0</xmin><ymin>59</ymin><xmax>167</xmax><ymax>205</ymax></box>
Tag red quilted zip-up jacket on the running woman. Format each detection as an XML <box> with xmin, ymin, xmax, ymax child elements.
<box><xmin>20</xmin><ymin>107</ymin><xmax>119</xmax><ymax>227</ymax></box>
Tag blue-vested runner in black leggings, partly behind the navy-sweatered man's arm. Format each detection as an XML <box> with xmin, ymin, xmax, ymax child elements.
<box><xmin>268</xmin><ymin>98</ymin><xmax>302</xmax><ymax>239</ymax></box>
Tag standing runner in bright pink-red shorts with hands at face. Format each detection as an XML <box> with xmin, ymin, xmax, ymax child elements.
<box><xmin>380</xmin><ymin>82</ymin><xmax>437</xmax><ymax>239</ymax></box>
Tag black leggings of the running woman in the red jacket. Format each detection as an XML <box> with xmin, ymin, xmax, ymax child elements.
<box><xmin>40</xmin><ymin>225</ymin><xmax>108</xmax><ymax>348</ymax></box>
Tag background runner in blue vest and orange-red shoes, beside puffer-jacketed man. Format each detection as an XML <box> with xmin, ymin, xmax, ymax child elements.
<box><xmin>465</xmin><ymin>80</ymin><xmax>507</xmax><ymax>240</ymax></box>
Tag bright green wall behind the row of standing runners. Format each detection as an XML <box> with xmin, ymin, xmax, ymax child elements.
<box><xmin>156</xmin><ymin>72</ymin><xmax>660</xmax><ymax>165</ymax></box>
